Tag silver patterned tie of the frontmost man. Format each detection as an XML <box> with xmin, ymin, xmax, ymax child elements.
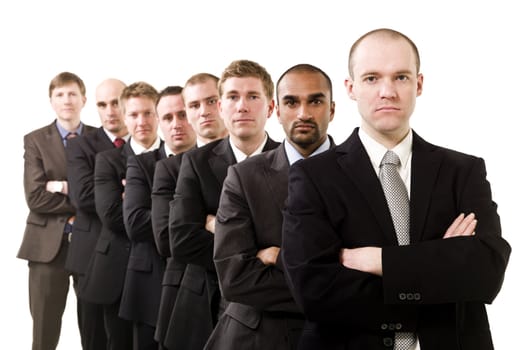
<box><xmin>379</xmin><ymin>151</ymin><xmax>416</xmax><ymax>350</ymax></box>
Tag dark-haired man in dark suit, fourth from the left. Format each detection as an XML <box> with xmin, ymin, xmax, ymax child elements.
<box><xmin>121</xmin><ymin>86</ymin><xmax>196</xmax><ymax>350</ymax></box>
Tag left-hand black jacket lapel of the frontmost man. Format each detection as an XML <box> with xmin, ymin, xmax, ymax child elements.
<box><xmin>336</xmin><ymin>129</ymin><xmax>397</xmax><ymax>245</ymax></box>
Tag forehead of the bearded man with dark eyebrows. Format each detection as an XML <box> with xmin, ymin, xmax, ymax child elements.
<box><xmin>278</xmin><ymin>71</ymin><xmax>329</xmax><ymax>98</ymax></box>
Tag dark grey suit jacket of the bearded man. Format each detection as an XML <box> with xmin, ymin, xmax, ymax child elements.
<box><xmin>207</xmin><ymin>143</ymin><xmax>322</xmax><ymax>350</ymax></box>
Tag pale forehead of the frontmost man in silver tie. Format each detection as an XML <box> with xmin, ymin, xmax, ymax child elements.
<box><xmin>352</xmin><ymin>35</ymin><xmax>417</xmax><ymax>76</ymax></box>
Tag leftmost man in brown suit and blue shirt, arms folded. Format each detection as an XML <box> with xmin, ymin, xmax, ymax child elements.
<box><xmin>17</xmin><ymin>72</ymin><xmax>94</xmax><ymax>350</ymax></box>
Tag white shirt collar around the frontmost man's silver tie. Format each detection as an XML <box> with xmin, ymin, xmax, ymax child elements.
<box><xmin>359</xmin><ymin>129</ymin><xmax>413</xmax><ymax>169</ymax></box>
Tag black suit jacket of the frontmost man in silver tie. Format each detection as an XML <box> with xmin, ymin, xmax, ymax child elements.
<box><xmin>282</xmin><ymin>130</ymin><xmax>510</xmax><ymax>350</ymax></box>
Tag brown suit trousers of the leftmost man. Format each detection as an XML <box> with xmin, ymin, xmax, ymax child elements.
<box><xmin>28</xmin><ymin>239</ymin><xmax>70</xmax><ymax>350</ymax></box>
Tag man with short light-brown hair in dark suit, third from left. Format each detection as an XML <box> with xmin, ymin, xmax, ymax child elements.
<box><xmin>82</xmin><ymin>82</ymin><xmax>161</xmax><ymax>349</ymax></box>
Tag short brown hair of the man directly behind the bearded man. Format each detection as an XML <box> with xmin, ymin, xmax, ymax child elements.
<box><xmin>218</xmin><ymin>60</ymin><xmax>274</xmax><ymax>100</ymax></box>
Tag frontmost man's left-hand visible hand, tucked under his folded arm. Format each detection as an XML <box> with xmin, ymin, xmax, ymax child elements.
<box><xmin>339</xmin><ymin>247</ymin><xmax>382</xmax><ymax>276</ymax></box>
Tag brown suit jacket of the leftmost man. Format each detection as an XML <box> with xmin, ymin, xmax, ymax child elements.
<box><xmin>17</xmin><ymin>121</ymin><xmax>94</xmax><ymax>263</ymax></box>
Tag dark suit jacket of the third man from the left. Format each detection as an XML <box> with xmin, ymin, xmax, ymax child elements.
<box><xmin>81</xmin><ymin>142</ymin><xmax>134</xmax><ymax>304</ymax></box>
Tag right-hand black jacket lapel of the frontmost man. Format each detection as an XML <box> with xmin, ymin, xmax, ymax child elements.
<box><xmin>410</xmin><ymin>132</ymin><xmax>443</xmax><ymax>243</ymax></box>
